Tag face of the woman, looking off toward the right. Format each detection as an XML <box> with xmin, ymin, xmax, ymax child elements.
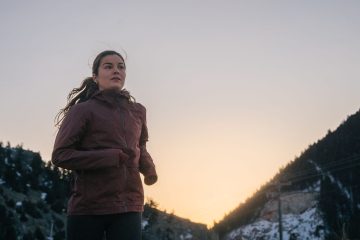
<box><xmin>93</xmin><ymin>54</ymin><xmax>126</xmax><ymax>90</ymax></box>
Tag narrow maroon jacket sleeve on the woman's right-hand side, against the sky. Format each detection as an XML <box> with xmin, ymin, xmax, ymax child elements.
<box><xmin>139</xmin><ymin>104</ymin><xmax>157</xmax><ymax>185</ymax></box>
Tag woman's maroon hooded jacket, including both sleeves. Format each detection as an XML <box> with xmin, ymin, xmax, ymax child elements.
<box><xmin>51</xmin><ymin>90</ymin><xmax>157</xmax><ymax>215</ymax></box>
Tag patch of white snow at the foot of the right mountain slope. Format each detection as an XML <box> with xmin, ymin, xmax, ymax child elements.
<box><xmin>226</xmin><ymin>207</ymin><xmax>325</xmax><ymax>240</ymax></box>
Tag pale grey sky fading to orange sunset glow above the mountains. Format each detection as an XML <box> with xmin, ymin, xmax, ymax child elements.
<box><xmin>0</xmin><ymin>0</ymin><xmax>360</xmax><ymax>226</ymax></box>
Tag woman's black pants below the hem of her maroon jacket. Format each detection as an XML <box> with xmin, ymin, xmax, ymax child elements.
<box><xmin>66</xmin><ymin>212</ymin><xmax>141</xmax><ymax>240</ymax></box>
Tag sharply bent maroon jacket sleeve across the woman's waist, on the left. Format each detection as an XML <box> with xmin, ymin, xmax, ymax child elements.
<box><xmin>51</xmin><ymin>104</ymin><xmax>126</xmax><ymax>170</ymax></box>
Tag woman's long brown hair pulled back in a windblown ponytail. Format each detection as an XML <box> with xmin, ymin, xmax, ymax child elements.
<box><xmin>55</xmin><ymin>50</ymin><xmax>135</xmax><ymax>127</ymax></box>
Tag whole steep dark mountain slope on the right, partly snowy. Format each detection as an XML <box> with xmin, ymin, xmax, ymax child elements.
<box><xmin>214</xmin><ymin>109</ymin><xmax>360</xmax><ymax>240</ymax></box>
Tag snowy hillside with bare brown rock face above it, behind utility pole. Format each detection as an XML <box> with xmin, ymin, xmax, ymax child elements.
<box><xmin>224</xmin><ymin>182</ymin><xmax>325</xmax><ymax>240</ymax></box>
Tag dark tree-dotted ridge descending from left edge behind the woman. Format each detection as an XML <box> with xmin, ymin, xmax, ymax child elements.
<box><xmin>0</xmin><ymin>143</ymin><xmax>214</xmax><ymax>240</ymax></box>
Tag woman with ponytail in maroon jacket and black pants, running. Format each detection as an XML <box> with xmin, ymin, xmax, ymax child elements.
<box><xmin>51</xmin><ymin>51</ymin><xmax>157</xmax><ymax>240</ymax></box>
